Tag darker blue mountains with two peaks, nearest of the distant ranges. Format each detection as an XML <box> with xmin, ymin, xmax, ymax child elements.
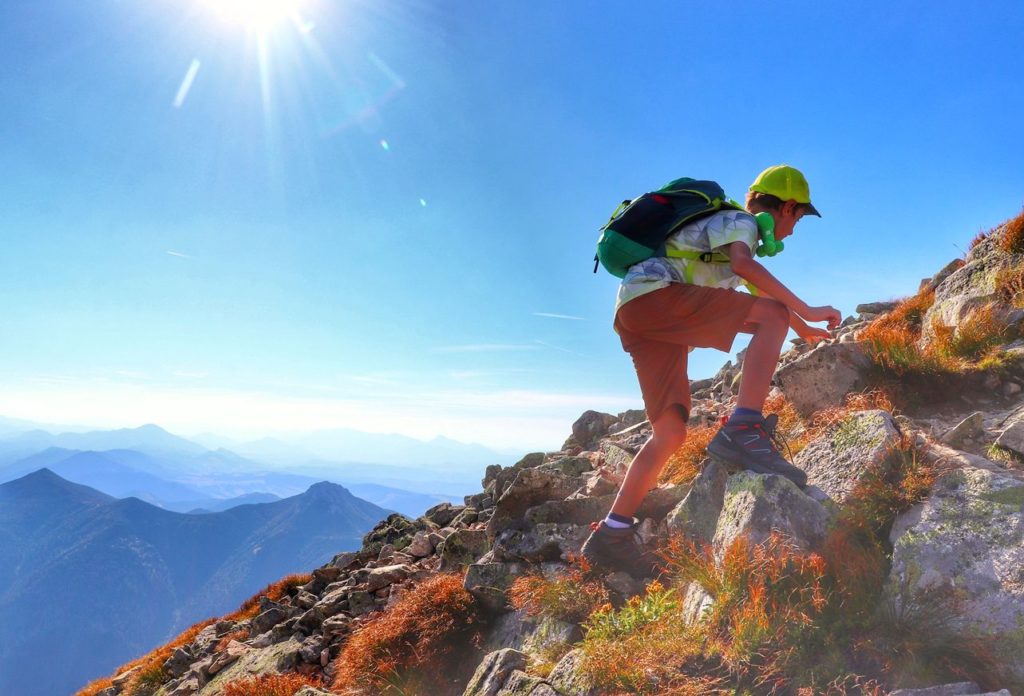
<box><xmin>0</xmin><ymin>466</ymin><xmax>388</xmax><ymax>694</ymax></box>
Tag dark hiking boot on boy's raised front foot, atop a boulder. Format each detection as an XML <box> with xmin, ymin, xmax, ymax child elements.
<box><xmin>708</xmin><ymin>414</ymin><xmax>807</xmax><ymax>488</ymax></box>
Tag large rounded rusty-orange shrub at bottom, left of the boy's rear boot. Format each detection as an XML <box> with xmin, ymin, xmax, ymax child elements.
<box><xmin>334</xmin><ymin>574</ymin><xmax>479</xmax><ymax>695</ymax></box>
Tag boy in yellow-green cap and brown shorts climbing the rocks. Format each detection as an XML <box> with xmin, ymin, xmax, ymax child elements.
<box><xmin>582</xmin><ymin>165</ymin><xmax>842</xmax><ymax>574</ymax></box>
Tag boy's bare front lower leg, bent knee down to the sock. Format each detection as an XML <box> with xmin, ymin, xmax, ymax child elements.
<box><xmin>736</xmin><ymin>298</ymin><xmax>790</xmax><ymax>410</ymax></box>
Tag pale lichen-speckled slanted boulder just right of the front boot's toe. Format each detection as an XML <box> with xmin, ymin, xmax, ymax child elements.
<box><xmin>794</xmin><ymin>409</ymin><xmax>900</xmax><ymax>504</ymax></box>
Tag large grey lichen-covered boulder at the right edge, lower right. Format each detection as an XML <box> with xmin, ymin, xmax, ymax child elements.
<box><xmin>887</xmin><ymin>449</ymin><xmax>1024</xmax><ymax>678</ymax></box>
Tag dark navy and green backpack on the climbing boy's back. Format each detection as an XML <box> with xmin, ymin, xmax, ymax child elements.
<box><xmin>594</xmin><ymin>177</ymin><xmax>743</xmax><ymax>277</ymax></box>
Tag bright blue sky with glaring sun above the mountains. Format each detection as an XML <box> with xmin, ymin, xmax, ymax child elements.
<box><xmin>0</xmin><ymin>0</ymin><xmax>1024</xmax><ymax>449</ymax></box>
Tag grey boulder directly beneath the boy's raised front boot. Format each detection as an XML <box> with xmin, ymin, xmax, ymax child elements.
<box><xmin>712</xmin><ymin>471</ymin><xmax>829</xmax><ymax>559</ymax></box>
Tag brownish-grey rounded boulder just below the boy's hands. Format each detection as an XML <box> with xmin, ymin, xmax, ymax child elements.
<box><xmin>775</xmin><ymin>343</ymin><xmax>871</xmax><ymax>417</ymax></box>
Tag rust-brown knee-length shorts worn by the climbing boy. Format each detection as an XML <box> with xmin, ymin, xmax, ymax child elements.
<box><xmin>614</xmin><ymin>282</ymin><xmax>757</xmax><ymax>422</ymax></box>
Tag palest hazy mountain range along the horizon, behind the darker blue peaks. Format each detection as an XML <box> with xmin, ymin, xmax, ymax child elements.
<box><xmin>0</xmin><ymin>418</ymin><xmax>517</xmax><ymax>505</ymax></box>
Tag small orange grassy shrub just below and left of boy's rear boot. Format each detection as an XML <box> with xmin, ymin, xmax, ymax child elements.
<box><xmin>509</xmin><ymin>557</ymin><xmax>608</xmax><ymax>623</ymax></box>
